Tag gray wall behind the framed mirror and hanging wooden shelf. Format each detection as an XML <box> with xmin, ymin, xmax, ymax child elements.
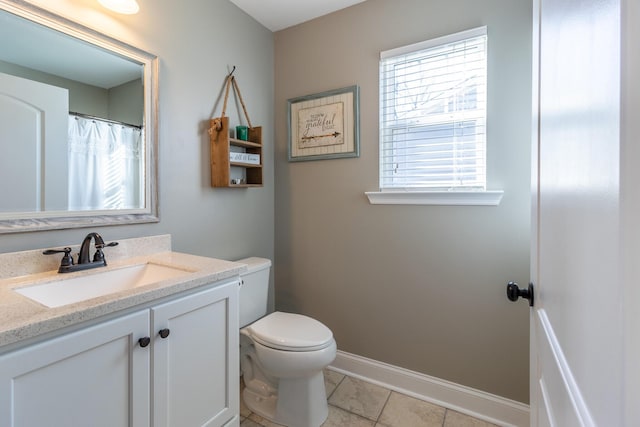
<box><xmin>0</xmin><ymin>0</ymin><xmax>274</xmax><ymax>298</ymax></box>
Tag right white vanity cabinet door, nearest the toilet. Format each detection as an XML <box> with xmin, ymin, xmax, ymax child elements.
<box><xmin>151</xmin><ymin>280</ymin><xmax>240</xmax><ymax>427</ymax></box>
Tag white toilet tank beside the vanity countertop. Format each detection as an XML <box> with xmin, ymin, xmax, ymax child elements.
<box><xmin>235</xmin><ymin>257</ymin><xmax>271</xmax><ymax>328</ymax></box>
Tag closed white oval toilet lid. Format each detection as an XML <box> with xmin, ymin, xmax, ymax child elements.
<box><xmin>246</xmin><ymin>311</ymin><xmax>333</xmax><ymax>351</ymax></box>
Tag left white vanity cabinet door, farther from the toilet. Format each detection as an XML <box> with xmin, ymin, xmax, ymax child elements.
<box><xmin>0</xmin><ymin>311</ymin><xmax>150</xmax><ymax>427</ymax></box>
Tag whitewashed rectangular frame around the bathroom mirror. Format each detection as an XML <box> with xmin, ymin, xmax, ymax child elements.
<box><xmin>0</xmin><ymin>0</ymin><xmax>160</xmax><ymax>234</ymax></box>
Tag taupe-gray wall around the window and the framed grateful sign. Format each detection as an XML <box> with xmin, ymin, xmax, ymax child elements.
<box><xmin>275</xmin><ymin>0</ymin><xmax>532</xmax><ymax>402</ymax></box>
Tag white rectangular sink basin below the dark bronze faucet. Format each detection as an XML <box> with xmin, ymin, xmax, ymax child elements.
<box><xmin>14</xmin><ymin>263</ymin><xmax>191</xmax><ymax>307</ymax></box>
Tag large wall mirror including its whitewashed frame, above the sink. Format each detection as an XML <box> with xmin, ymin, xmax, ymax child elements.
<box><xmin>0</xmin><ymin>0</ymin><xmax>158</xmax><ymax>233</ymax></box>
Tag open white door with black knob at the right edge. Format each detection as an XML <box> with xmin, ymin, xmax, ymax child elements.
<box><xmin>531</xmin><ymin>0</ymin><xmax>640</xmax><ymax>427</ymax></box>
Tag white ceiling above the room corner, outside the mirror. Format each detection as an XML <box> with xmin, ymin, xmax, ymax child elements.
<box><xmin>231</xmin><ymin>0</ymin><xmax>364</xmax><ymax>31</ymax></box>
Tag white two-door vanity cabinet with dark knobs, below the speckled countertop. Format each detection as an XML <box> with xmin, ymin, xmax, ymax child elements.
<box><xmin>0</xmin><ymin>279</ymin><xmax>239</xmax><ymax>427</ymax></box>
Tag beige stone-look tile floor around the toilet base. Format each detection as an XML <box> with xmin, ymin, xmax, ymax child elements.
<box><xmin>240</xmin><ymin>369</ymin><xmax>495</xmax><ymax>427</ymax></box>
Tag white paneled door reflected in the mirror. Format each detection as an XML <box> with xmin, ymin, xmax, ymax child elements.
<box><xmin>0</xmin><ymin>73</ymin><xmax>69</xmax><ymax>214</ymax></box>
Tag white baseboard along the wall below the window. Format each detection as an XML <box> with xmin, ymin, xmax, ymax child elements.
<box><xmin>329</xmin><ymin>351</ymin><xmax>529</xmax><ymax>427</ymax></box>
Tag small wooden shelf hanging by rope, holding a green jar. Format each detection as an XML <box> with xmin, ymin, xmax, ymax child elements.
<box><xmin>209</xmin><ymin>66</ymin><xmax>262</xmax><ymax>188</ymax></box>
